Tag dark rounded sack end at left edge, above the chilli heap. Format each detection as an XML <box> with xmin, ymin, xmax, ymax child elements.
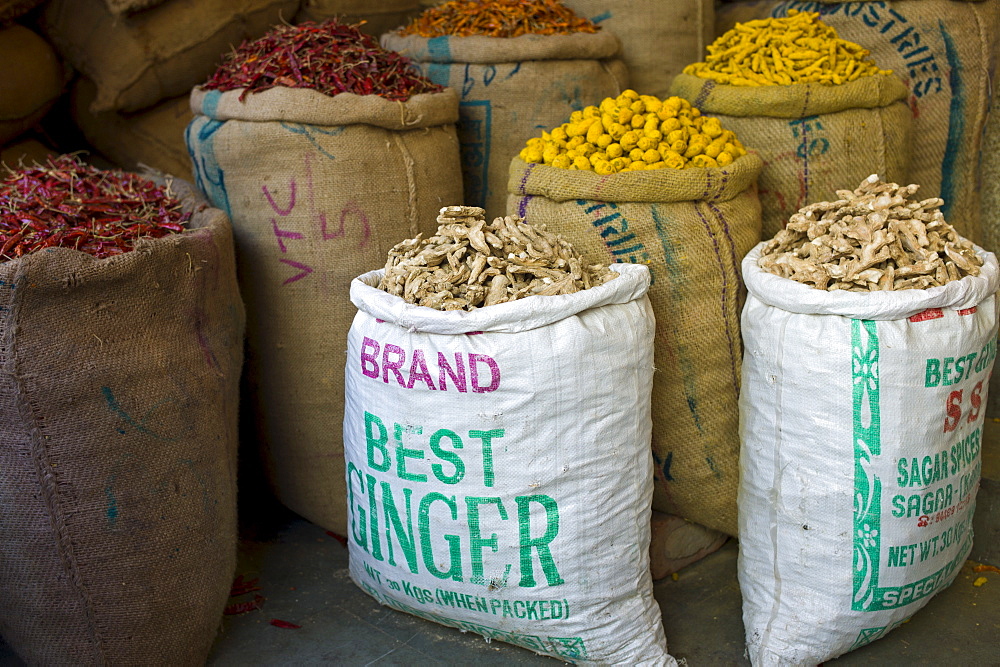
<box><xmin>0</xmin><ymin>24</ymin><xmax>68</xmax><ymax>144</ymax></box>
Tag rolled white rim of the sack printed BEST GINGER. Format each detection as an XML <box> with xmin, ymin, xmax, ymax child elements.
<box><xmin>351</xmin><ymin>264</ymin><xmax>650</xmax><ymax>334</ymax></box>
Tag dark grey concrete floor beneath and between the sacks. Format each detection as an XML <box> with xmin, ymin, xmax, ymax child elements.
<box><xmin>197</xmin><ymin>504</ymin><xmax>1000</xmax><ymax>667</ymax></box>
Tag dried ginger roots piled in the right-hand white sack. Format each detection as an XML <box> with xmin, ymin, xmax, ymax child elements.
<box><xmin>757</xmin><ymin>174</ymin><xmax>983</xmax><ymax>292</ymax></box>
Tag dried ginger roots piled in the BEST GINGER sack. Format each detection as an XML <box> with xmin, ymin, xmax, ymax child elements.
<box><xmin>379</xmin><ymin>206</ymin><xmax>618</xmax><ymax>310</ymax></box>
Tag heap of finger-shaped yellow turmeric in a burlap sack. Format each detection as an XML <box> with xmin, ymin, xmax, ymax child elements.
<box><xmin>684</xmin><ymin>9</ymin><xmax>892</xmax><ymax>86</ymax></box>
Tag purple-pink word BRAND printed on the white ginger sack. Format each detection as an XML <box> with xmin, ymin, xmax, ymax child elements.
<box><xmin>360</xmin><ymin>336</ymin><xmax>500</xmax><ymax>394</ymax></box>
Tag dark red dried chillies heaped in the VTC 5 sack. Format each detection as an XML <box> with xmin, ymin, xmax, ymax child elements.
<box><xmin>202</xmin><ymin>19</ymin><xmax>443</xmax><ymax>101</ymax></box>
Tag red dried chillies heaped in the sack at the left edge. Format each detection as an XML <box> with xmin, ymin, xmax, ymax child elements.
<box><xmin>0</xmin><ymin>155</ymin><xmax>191</xmax><ymax>260</ymax></box>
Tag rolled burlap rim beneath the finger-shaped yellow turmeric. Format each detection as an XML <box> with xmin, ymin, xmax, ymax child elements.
<box><xmin>670</xmin><ymin>73</ymin><xmax>910</xmax><ymax>118</ymax></box>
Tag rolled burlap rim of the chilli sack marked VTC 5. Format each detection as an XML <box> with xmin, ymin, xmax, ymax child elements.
<box><xmin>191</xmin><ymin>86</ymin><xmax>458</xmax><ymax>130</ymax></box>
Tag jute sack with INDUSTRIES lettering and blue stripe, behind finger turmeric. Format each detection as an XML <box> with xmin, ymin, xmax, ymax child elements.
<box><xmin>772</xmin><ymin>0</ymin><xmax>1000</xmax><ymax>245</ymax></box>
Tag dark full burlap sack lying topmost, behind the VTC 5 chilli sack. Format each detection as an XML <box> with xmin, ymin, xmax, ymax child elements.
<box><xmin>40</xmin><ymin>0</ymin><xmax>298</xmax><ymax>111</ymax></box>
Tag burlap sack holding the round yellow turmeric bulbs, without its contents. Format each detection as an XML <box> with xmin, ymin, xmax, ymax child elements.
<box><xmin>507</xmin><ymin>153</ymin><xmax>762</xmax><ymax>535</ymax></box>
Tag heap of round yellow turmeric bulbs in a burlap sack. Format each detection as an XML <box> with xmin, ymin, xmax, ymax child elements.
<box><xmin>520</xmin><ymin>90</ymin><xmax>746</xmax><ymax>176</ymax></box>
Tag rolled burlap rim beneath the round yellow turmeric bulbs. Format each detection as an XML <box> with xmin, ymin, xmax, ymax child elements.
<box><xmin>507</xmin><ymin>151</ymin><xmax>764</xmax><ymax>204</ymax></box>
